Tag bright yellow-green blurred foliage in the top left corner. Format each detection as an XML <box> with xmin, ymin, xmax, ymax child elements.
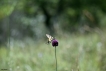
<box><xmin>0</xmin><ymin>0</ymin><xmax>16</xmax><ymax>20</ymax></box>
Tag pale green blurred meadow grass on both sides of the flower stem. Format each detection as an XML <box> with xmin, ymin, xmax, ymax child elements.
<box><xmin>0</xmin><ymin>32</ymin><xmax>106</xmax><ymax>71</ymax></box>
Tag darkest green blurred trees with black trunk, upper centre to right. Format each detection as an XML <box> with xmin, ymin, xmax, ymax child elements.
<box><xmin>21</xmin><ymin>0</ymin><xmax>106</xmax><ymax>33</ymax></box>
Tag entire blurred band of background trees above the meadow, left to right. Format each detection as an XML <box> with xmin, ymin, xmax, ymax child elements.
<box><xmin>0</xmin><ymin>0</ymin><xmax>106</xmax><ymax>44</ymax></box>
